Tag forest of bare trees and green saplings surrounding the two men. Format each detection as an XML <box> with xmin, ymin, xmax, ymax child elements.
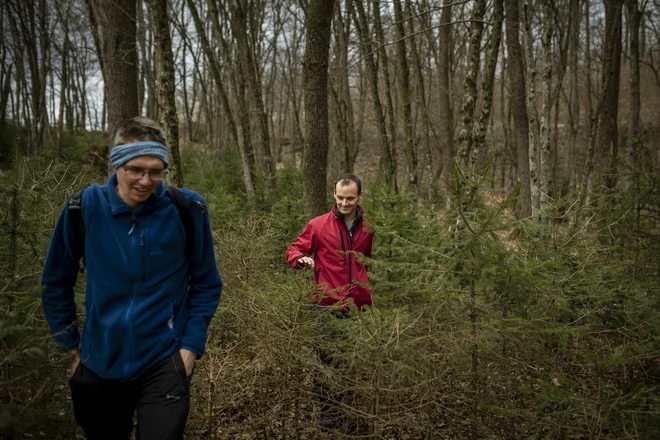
<box><xmin>0</xmin><ymin>0</ymin><xmax>660</xmax><ymax>439</ymax></box>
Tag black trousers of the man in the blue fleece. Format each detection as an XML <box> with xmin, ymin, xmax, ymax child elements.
<box><xmin>69</xmin><ymin>350</ymin><xmax>190</xmax><ymax>440</ymax></box>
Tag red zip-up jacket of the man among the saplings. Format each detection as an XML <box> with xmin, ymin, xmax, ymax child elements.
<box><xmin>286</xmin><ymin>205</ymin><xmax>374</xmax><ymax>309</ymax></box>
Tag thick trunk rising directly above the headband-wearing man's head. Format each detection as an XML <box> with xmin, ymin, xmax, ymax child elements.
<box><xmin>86</xmin><ymin>0</ymin><xmax>140</xmax><ymax>141</ymax></box>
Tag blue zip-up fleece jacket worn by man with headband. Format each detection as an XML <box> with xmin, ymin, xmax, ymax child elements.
<box><xmin>41</xmin><ymin>174</ymin><xmax>222</xmax><ymax>380</ymax></box>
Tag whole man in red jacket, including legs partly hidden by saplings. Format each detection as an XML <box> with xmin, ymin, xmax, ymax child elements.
<box><xmin>286</xmin><ymin>174</ymin><xmax>374</xmax><ymax>431</ymax></box>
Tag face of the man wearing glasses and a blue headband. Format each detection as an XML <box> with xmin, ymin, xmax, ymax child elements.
<box><xmin>117</xmin><ymin>156</ymin><xmax>165</xmax><ymax>208</ymax></box>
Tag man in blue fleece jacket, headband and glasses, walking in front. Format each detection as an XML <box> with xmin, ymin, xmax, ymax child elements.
<box><xmin>41</xmin><ymin>117</ymin><xmax>222</xmax><ymax>440</ymax></box>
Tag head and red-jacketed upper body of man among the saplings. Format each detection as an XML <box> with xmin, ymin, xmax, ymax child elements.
<box><xmin>286</xmin><ymin>174</ymin><xmax>374</xmax><ymax>311</ymax></box>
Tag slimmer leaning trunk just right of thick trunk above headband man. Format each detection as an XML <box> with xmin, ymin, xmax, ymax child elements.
<box><xmin>148</xmin><ymin>0</ymin><xmax>183</xmax><ymax>187</ymax></box>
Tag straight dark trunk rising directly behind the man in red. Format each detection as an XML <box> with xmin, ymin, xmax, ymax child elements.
<box><xmin>303</xmin><ymin>0</ymin><xmax>335</xmax><ymax>217</ymax></box>
